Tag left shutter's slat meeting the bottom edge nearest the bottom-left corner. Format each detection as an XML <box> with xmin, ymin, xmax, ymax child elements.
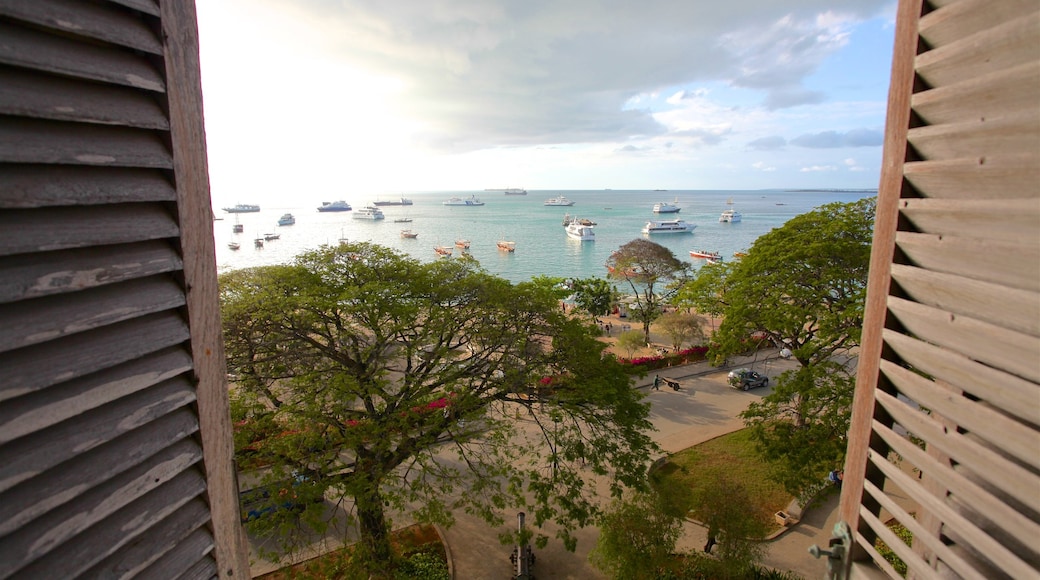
<box><xmin>19</xmin><ymin>470</ymin><xmax>206</xmax><ymax>578</ymax></box>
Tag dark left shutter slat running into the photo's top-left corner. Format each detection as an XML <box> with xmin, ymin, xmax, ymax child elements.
<box><xmin>0</xmin><ymin>0</ymin><xmax>162</xmax><ymax>54</ymax></box>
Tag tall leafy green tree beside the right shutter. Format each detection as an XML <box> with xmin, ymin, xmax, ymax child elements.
<box><xmin>685</xmin><ymin>199</ymin><xmax>875</xmax><ymax>495</ymax></box>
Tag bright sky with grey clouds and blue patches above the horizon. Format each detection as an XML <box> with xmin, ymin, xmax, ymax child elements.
<box><xmin>197</xmin><ymin>0</ymin><xmax>895</xmax><ymax>203</ymax></box>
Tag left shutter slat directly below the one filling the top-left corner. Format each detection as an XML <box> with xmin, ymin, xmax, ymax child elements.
<box><xmin>0</xmin><ymin>21</ymin><xmax>166</xmax><ymax>93</ymax></box>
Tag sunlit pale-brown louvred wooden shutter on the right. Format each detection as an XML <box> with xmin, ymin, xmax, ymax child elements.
<box><xmin>840</xmin><ymin>0</ymin><xmax>1040</xmax><ymax>579</ymax></box>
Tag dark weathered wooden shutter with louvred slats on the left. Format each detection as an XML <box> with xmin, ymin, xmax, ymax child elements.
<box><xmin>0</xmin><ymin>0</ymin><xmax>249</xmax><ymax>578</ymax></box>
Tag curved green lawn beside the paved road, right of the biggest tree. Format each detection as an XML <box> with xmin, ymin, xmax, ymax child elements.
<box><xmin>650</xmin><ymin>429</ymin><xmax>794</xmax><ymax>529</ymax></box>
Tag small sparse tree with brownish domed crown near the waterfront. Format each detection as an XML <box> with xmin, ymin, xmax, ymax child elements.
<box><xmin>606</xmin><ymin>239</ymin><xmax>690</xmax><ymax>343</ymax></box>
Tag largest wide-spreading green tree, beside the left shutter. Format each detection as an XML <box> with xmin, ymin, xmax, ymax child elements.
<box><xmin>220</xmin><ymin>243</ymin><xmax>655</xmax><ymax>574</ymax></box>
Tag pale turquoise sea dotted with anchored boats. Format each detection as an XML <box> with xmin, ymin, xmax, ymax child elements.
<box><xmin>213</xmin><ymin>189</ymin><xmax>877</xmax><ymax>283</ymax></box>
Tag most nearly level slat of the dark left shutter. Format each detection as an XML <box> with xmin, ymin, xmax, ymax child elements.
<box><xmin>0</xmin><ymin>164</ymin><xmax>177</xmax><ymax>209</ymax></box>
